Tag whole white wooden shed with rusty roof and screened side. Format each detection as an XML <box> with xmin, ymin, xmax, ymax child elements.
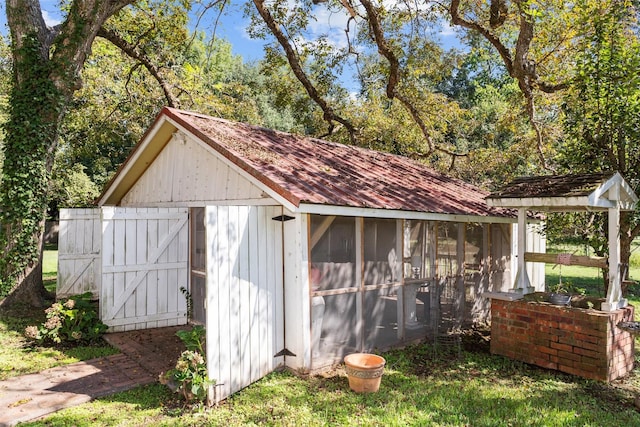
<box><xmin>58</xmin><ymin>108</ymin><xmax>545</xmax><ymax>400</ymax></box>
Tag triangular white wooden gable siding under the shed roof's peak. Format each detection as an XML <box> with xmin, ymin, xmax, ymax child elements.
<box><xmin>121</xmin><ymin>136</ymin><xmax>273</xmax><ymax>206</ymax></box>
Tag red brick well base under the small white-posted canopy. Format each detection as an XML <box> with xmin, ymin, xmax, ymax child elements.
<box><xmin>491</xmin><ymin>299</ymin><xmax>634</xmax><ymax>381</ymax></box>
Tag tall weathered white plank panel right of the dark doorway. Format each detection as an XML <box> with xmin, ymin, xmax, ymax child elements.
<box><xmin>205</xmin><ymin>206</ymin><xmax>284</xmax><ymax>400</ymax></box>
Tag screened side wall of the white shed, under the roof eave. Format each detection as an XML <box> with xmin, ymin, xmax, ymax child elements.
<box><xmin>309</xmin><ymin>215</ymin><xmax>512</xmax><ymax>369</ymax></box>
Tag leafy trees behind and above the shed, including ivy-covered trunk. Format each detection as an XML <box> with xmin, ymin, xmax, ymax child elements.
<box><xmin>0</xmin><ymin>0</ymin><xmax>640</xmax><ymax>303</ymax></box>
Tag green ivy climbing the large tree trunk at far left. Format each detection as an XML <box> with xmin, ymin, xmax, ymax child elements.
<box><xmin>0</xmin><ymin>33</ymin><xmax>62</xmax><ymax>298</ymax></box>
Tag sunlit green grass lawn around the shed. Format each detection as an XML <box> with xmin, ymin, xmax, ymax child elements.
<box><xmin>7</xmin><ymin>242</ymin><xmax>640</xmax><ymax>426</ymax></box>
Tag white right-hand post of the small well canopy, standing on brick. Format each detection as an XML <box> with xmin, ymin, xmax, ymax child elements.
<box><xmin>601</xmin><ymin>191</ymin><xmax>627</xmax><ymax>311</ymax></box>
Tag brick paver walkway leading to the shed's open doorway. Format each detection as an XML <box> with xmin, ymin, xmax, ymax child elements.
<box><xmin>0</xmin><ymin>326</ymin><xmax>187</xmax><ymax>427</ymax></box>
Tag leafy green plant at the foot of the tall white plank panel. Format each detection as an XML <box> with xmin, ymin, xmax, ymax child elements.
<box><xmin>161</xmin><ymin>325</ymin><xmax>216</xmax><ymax>402</ymax></box>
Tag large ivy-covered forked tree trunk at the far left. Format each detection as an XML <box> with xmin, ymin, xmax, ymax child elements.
<box><xmin>0</xmin><ymin>0</ymin><xmax>132</xmax><ymax>305</ymax></box>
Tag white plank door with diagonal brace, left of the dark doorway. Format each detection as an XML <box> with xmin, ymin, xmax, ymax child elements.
<box><xmin>100</xmin><ymin>207</ymin><xmax>189</xmax><ymax>332</ymax></box>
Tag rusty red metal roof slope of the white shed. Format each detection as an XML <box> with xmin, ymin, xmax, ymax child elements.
<box><xmin>163</xmin><ymin>108</ymin><xmax>512</xmax><ymax>217</ymax></box>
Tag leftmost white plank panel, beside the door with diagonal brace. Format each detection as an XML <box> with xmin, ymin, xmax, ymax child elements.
<box><xmin>56</xmin><ymin>209</ymin><xmax>102</xmax><ymax>298</ymax></box>
